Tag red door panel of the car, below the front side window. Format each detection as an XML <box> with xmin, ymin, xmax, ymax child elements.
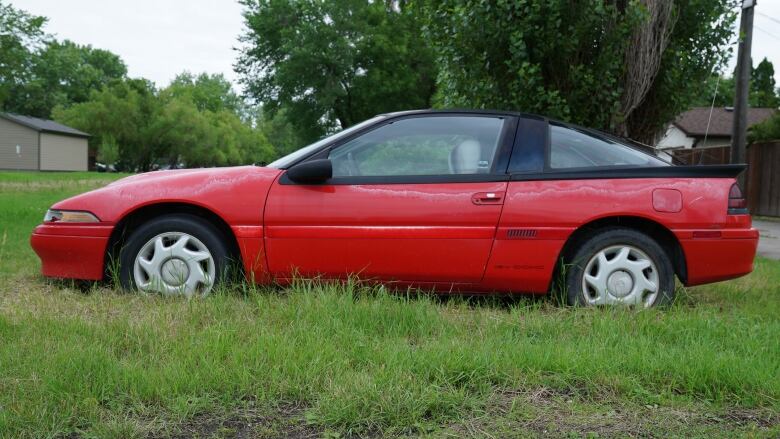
<box><xmin>265</xmin><ymin>182</ymin><xmax>507</xmax><ymax>283</ymax></box>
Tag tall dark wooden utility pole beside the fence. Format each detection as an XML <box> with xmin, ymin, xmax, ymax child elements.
<box><xmin>731</xmin><ymin>0</ymin><xmax>756</xmax><ymax>188</ymax></box>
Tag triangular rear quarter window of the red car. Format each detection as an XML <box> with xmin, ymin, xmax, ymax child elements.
<box><xmin>550</xmin><ymin>124</ymin><xmax>667</xmax><ymax>169</ymax></box>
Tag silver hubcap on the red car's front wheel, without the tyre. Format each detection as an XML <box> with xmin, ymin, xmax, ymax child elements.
<box><xmin>133</xmin><ymin>232</ymin><xmax>216</xmax><ymax>297</ymax></box>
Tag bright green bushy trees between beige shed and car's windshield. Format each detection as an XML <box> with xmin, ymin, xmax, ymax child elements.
<box><xmin>54</xmin><ymin>75</ymin><xmax>275</xmax><ymax>171</ymax></box>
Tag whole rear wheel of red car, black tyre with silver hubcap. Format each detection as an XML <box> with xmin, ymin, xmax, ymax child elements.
<box><xmin>564</xmin><ymin>228</ymin><xmax>674</xmax><ymax>308</ymax></box>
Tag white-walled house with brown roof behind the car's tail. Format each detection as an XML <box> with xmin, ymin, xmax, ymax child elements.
<box><xmin>656</xmin><ymin>107</ymin><xmax>777</xmax><ymax>150</ymax></box>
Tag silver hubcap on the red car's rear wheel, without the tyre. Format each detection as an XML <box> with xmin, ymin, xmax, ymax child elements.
<box><xmin>582</xmin><ymin>245</ymin><xmax>659</xmax><ymax>307</ymax></box>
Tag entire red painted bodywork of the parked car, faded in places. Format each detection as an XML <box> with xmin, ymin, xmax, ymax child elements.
<box><xmin>31</xmin><ymin>167</ymin><xmax>758</xmax><ymax>293</ymax></box>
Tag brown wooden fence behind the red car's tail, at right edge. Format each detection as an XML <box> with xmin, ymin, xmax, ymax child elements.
<box><xmin>673</xmin><ymin>140</ymin><xmax>780</xmax><ymax>216</ymax></box>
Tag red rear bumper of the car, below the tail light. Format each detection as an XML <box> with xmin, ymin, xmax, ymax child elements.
<box><xmin>675</xmin><ymin>228</ymin><xmax>758</xmax><ymax>286</ymax></box>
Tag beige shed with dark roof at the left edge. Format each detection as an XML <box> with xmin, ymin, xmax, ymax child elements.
<box><xmin>0</xmin><ymin>113</ymin><xmax>89</xmax><ymax>171</ymax></box>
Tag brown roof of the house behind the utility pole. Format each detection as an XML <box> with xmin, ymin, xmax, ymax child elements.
<box><xmin>673</xmin><ymin>107</ymin><xmax>777</xmax><ymax>137</ymax></box>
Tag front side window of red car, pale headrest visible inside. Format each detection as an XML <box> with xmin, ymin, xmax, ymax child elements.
<box><xmin>328</xmin><ymin>116</ymin><xmax>504</xmax><ymax>177</ymax></box>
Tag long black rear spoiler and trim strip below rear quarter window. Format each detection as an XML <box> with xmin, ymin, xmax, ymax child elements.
<box><xmin>510</xmin><ymin>164</ymin><xmax>747</xmax><ymax>181</ymax></box>
